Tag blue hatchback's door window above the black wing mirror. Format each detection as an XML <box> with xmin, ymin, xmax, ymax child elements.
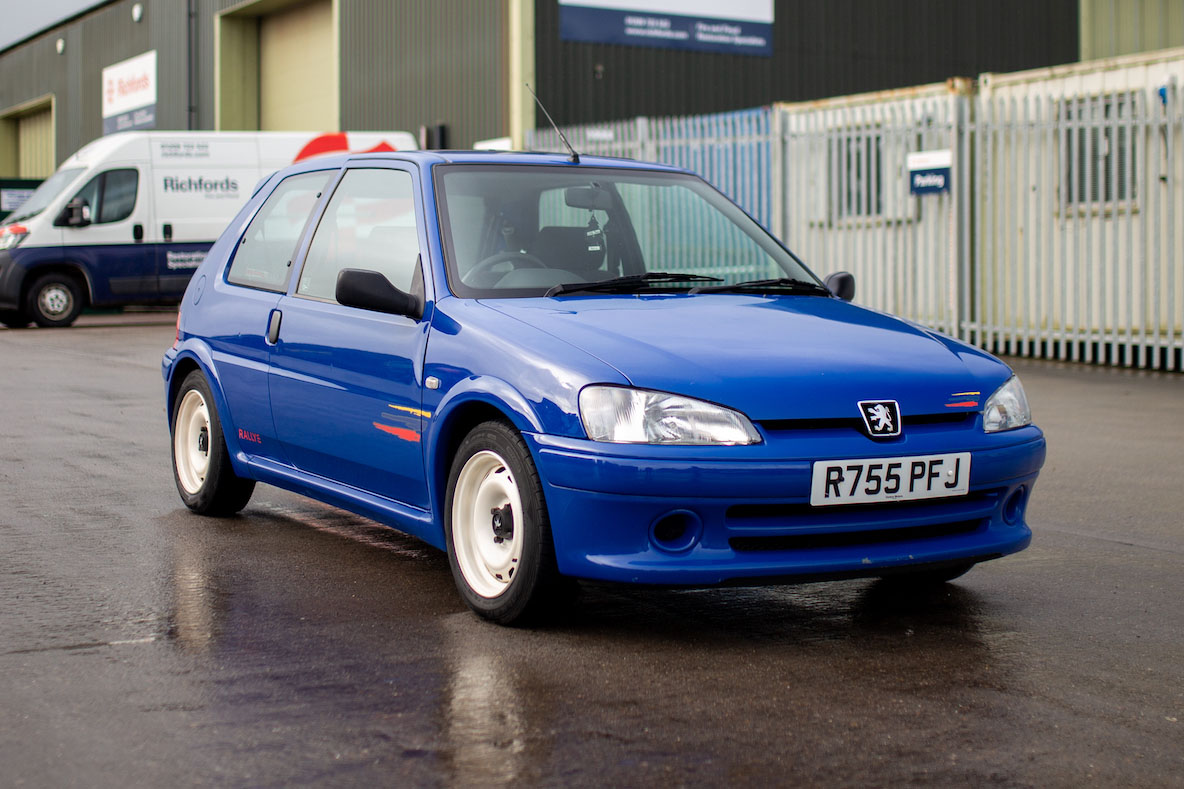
<box><xmin>296</xmin><ymin>169</ymin><xmax>419</xmax><ymax>301</ymax></box>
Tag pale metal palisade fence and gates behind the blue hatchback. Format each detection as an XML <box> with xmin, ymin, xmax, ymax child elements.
<box><xmin>528</xmin><ymin>79</ymin><xmax>1184</xmax><ymax>371</ymax></box>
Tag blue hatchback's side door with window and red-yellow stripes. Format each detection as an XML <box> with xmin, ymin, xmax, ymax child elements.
<box><xmin>270</xmin><ymin>162</ymin><xmax>429</xmax><ymax>508</ymax></box>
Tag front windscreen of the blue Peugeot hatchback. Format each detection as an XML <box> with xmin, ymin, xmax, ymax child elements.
<box><xmin>436</xmin><ymin>165</ymin><xmax>817</xmax><ymax>297</ymax></box>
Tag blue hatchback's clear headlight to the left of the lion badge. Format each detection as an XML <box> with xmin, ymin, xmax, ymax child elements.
<box><xmin>580</xmin><ymin>386</ymin><xmax>760</xmax><ymax>444</ymax></box>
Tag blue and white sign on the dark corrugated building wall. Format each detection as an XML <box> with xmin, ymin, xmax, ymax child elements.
<box><xmin>559</xmin><ymin>0</ymin><xmax>773</xmax><ymax>57</ymax></box>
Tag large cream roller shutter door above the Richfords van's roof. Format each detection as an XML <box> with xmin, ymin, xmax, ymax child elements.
<box><xmin>259</xmin><ymin>0</ymin><xmax>337</xmax><ymax>132</ymax></box>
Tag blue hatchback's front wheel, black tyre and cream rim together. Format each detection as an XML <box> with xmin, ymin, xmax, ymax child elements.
<box><xmin>444</xmin><ymin>422</ymin><xmax>571</xmax><ymax>624</ymax></box>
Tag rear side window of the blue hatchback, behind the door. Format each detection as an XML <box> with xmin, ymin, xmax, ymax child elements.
<box><xmin>226</xmin><ymin>171</ymin><xmax>333</xmax><ymax>291</ymax></box>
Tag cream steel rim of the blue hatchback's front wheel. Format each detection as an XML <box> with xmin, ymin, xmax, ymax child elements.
<box><xmin>452</xmin><ymin>450</ymin><xmax>525</xmax><ymax>598</ymax></box>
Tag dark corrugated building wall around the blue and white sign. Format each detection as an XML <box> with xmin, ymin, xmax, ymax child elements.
<box><xmin>535</xmin><ymin>0</ymin><xmax>1079</xmax><ymax>123</ymax></box>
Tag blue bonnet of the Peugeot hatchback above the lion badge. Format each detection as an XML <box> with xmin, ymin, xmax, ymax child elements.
<box><xmin>484</xmin><ymin>294</ymin><xmax>1010</xmax><ymax>419</ymax></box>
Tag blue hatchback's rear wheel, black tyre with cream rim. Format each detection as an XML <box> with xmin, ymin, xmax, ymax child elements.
<box><xmin>172</xmin><ymin>370</ymin><xmax>255</xmax><ymax>515</ymax></box>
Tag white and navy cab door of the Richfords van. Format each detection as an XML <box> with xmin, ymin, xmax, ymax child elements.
<box><xmin>62</xmin><ymin>167</ymin><xmax>159</xmax><ymax>304</ymax></box>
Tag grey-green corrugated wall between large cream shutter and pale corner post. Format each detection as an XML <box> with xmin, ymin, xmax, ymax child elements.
<box><xmin>341</xmin><ymin>0</ymin><xmax>509</xmax><ymax>148</ymax></box>
